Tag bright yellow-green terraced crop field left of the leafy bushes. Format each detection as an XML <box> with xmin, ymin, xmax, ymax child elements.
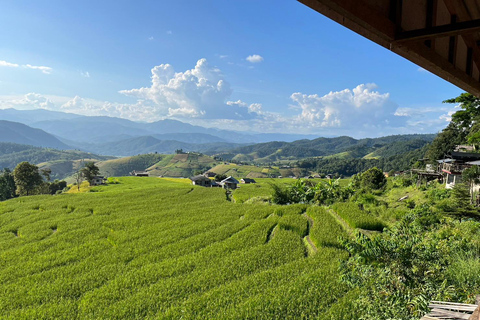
<box><xmin>0</xmin><ymin>177</ymin><xmax>356</xmax><ymax>319</ymax></box>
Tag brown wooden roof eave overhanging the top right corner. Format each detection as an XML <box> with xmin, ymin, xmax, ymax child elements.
<box><xmin>298</xmin><ymin>0</ymin><xmax>480</xmax><ymax>97</ymax></box>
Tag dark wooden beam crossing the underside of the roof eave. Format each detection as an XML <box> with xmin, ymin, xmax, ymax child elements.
<box><xmin>395</xmin><ymin>19</ymin><xmax>480</xmax><ymax>43</ymax></box>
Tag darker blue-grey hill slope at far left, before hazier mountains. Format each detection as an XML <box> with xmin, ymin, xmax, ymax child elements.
<box><xmin>0</xmin><ymin>120</ymin><xmax>71</xmax><ymax>149</ymax></box>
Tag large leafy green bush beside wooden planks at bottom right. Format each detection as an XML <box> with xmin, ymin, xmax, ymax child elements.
<box><xmin>343</xmin><ymin>206</ymin><xmax>478</xmax><ymax>319</ymax></box>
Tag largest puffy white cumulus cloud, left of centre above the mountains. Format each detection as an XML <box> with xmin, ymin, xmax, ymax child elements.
<box><xmin>120</xmin><ymin>59</ymin><xmax>256</xmax><ymax>119</ymax></box>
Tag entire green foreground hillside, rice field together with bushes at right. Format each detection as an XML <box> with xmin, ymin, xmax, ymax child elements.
<box><xmin>0</xmin><ymin>171</ymin><xmax>480</xmax><ymax>320</ymax></box>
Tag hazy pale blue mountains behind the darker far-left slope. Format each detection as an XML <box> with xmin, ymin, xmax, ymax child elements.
<box><xmin>0</xmin><ymin>109</ymin><xmax>322</xmax><ymax>156</ymax></box>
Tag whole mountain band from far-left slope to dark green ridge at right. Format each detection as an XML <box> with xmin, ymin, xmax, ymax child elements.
<box><xmin>0</xmin><ymin>109</ymin><xmax>435</xmax><ymax>163</ymax></box>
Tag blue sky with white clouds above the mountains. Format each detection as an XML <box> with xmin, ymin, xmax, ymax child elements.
<box><xmin>0</xmin><ymin>0</ymin><xmax>462</xmax><ymax>137</ymax></box>
